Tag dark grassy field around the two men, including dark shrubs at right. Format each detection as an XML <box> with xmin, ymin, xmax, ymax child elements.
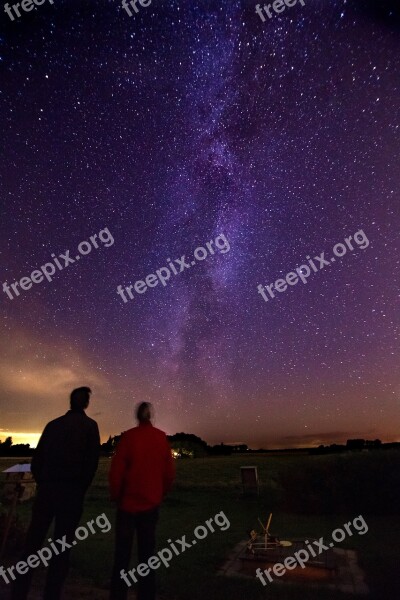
<box><xmin>0</xmin><ymin>451</ymin><xmax>400</xmax><ymax>600</ymax></box>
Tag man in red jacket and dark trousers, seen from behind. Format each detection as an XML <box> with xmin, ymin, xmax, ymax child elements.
<box><xmin>109</xmin><ymin>402</ymin><xmax>175</xmax><ymax>600</ymax></box>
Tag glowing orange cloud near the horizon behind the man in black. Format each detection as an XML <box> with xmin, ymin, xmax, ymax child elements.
<box><xmin>0</xmin><ymin>332</ymin><xmax>109</xmax><ymax>436</ymax></box>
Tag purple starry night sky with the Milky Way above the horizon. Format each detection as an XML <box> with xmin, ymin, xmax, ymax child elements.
<box><xmin>0</xmin><ymin>0</ymin><xmax>400</xmax><ymax>448</ymax></box>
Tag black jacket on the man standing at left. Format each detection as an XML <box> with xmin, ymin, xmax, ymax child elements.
<box><xmin>31</xmin><ymin>410</ymin><xmax>100</xmax><ymax>490</ymax></box>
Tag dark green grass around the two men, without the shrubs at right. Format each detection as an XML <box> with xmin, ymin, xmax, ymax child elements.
<box><xmin>0</xmin><ymin>453</ymin><xmax>400</xmax><ymax>600</ymax></box>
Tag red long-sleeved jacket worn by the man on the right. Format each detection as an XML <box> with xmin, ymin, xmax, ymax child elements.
<box><xmin>109</xmin><ymin>423</ymin><xmax>175</xmax><ymax>513</ymax></box>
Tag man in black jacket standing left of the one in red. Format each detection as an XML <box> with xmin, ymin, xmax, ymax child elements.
<box><xmin>11</xmin><ymin>387</ymin><xmax>100</xmax><ymax>600</ymax></box>
